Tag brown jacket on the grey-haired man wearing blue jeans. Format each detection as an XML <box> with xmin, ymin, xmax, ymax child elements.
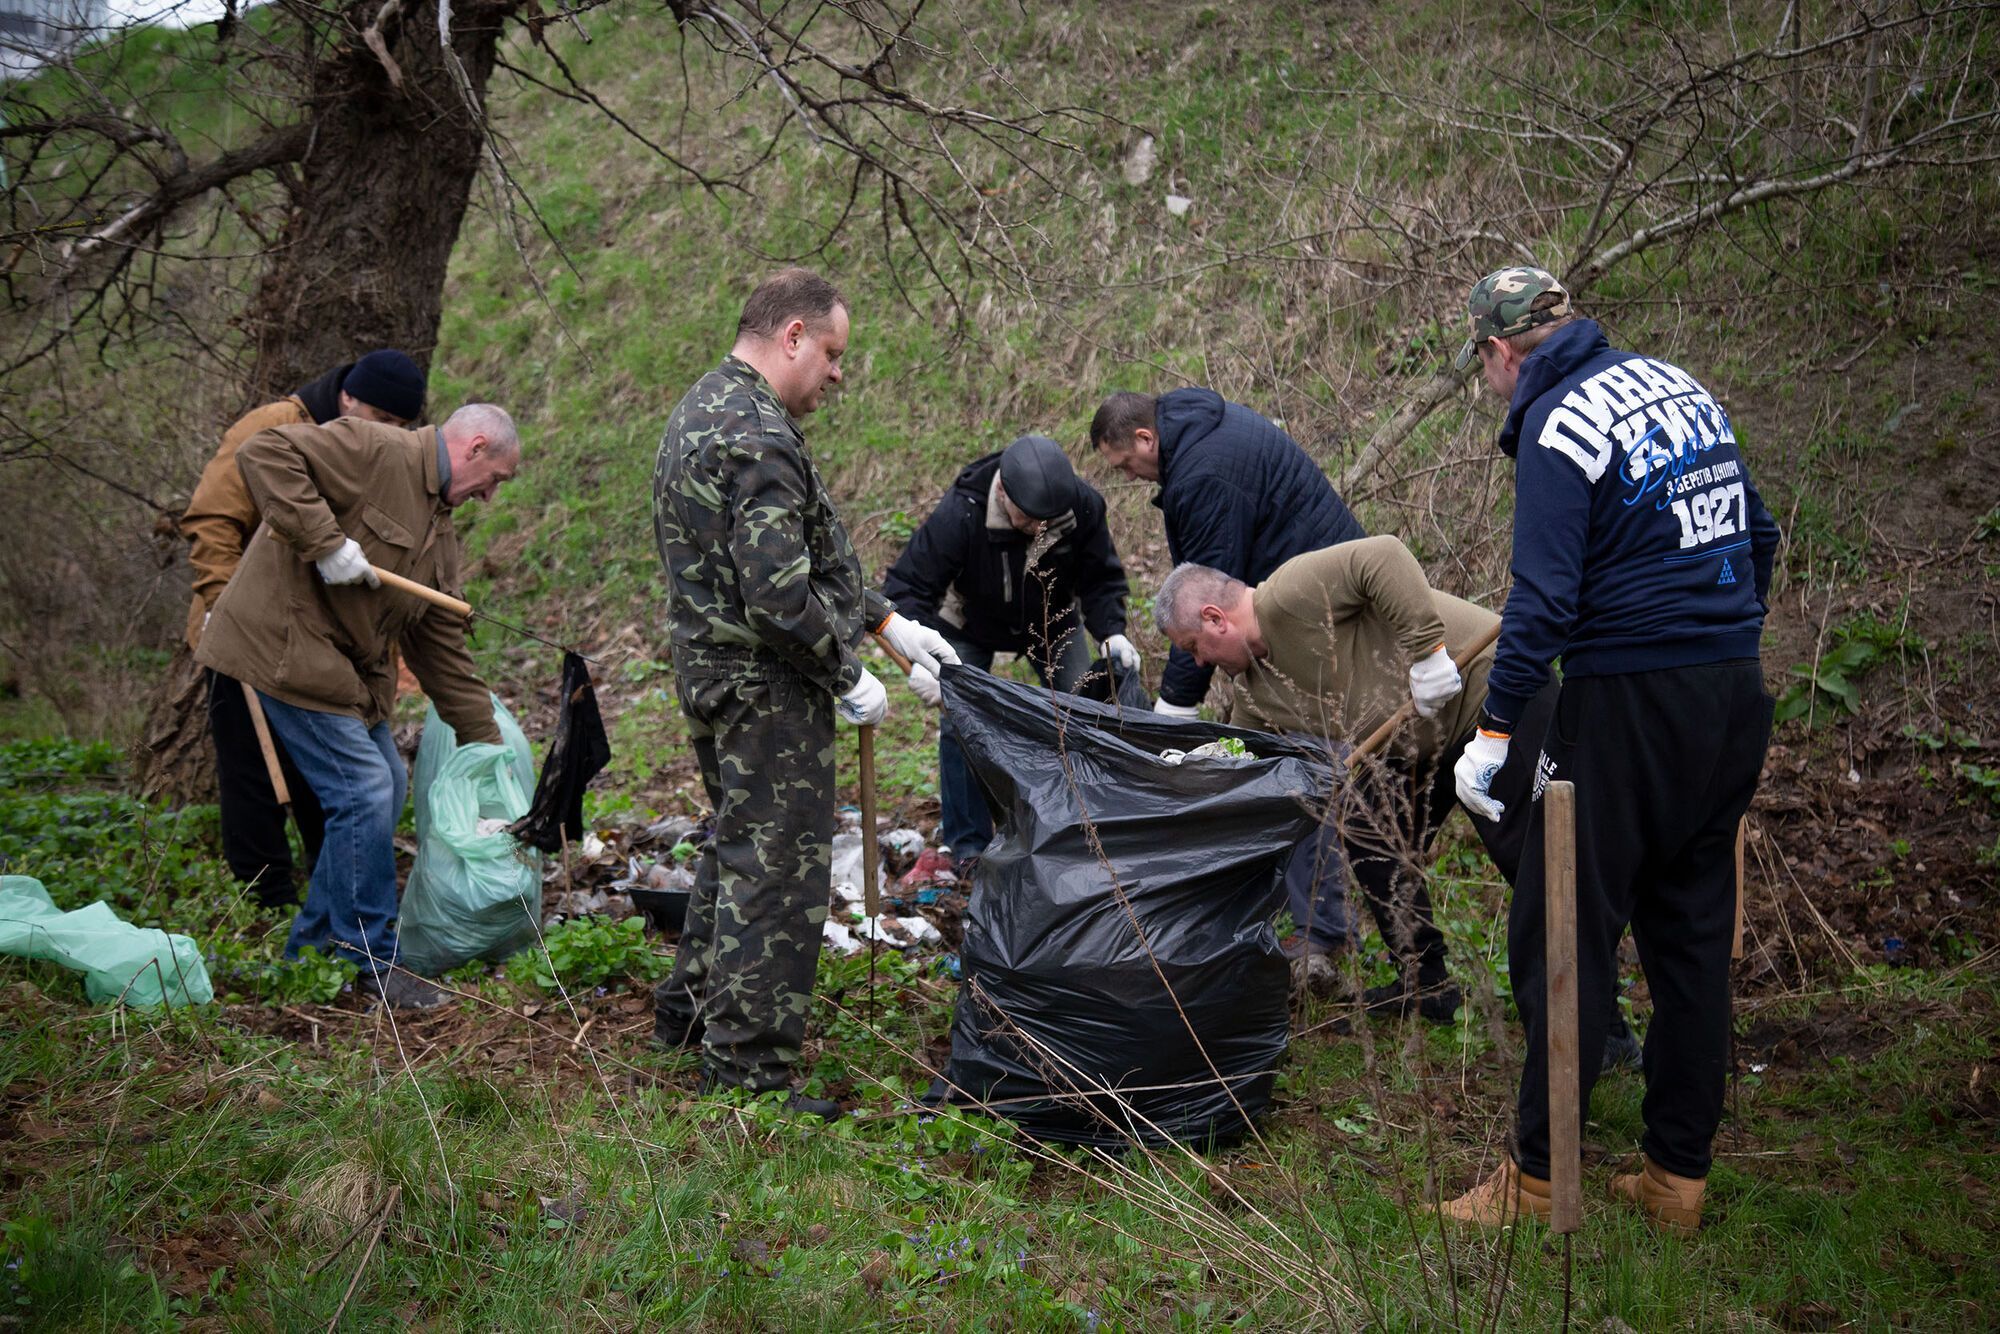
<box><xmin>194</xmin><ymin>416</ymin><xmax>500</xmax><ymax>742</ymax></box>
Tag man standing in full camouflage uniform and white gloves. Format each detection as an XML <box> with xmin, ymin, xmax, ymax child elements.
<box><xmin>652</xmin><ymin>268</ymin><xmax>958</xmax><ymax>1116</ymax></box>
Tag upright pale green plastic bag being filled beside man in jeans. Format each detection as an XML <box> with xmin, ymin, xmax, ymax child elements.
<box><xmin>396</xmin><ymin>696</ymin><xmax>542</xmax><ymax>976</ymax></box>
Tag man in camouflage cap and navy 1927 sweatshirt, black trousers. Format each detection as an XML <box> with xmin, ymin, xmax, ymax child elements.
<box><xmin>1442</xmin><ymin>266</ymin><xmax>1778</xmax><ymax>1232</ymax></box>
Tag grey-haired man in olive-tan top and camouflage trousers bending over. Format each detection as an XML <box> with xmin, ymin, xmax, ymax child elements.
<box><xmin>1154</xmin><ymin>538</ymin><xmax>1530</xmax><ymax>1022</ymax></box>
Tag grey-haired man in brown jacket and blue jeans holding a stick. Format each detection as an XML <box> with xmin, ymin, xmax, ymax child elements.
<box><xmin>194</xmin><ymin>404</ymin><xmax>520</xmax><ymax>1006</ymax></box>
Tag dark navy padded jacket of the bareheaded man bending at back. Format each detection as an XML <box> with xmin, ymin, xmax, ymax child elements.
<box><xmin>1152</xmin><ymin>390</ymin><xmax>1368</xmax><ymax>704</ymax></box>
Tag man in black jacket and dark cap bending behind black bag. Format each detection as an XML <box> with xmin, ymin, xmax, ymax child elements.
<box><xmin>882</xmin><ymin>436</ymin><xmax>1140</xmax><ymax>860</ymax></box>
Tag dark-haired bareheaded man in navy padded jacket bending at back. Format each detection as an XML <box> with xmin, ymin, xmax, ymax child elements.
<box><xmin>1090</xmin><ymin>388</ymin><xmax>1368</xmax><ymax>990</ymax></box>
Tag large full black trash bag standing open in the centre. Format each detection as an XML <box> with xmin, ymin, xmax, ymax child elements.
<box><xmin>944</xmin><ymin>666</ymin><xmax>1332</xmax><ymax>1148</ymax></box>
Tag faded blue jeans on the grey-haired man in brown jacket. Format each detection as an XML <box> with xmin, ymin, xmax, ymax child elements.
<box><xmin>258</xmin><ymin>690</ymin><xmax>410</xmax><ymax>974</ymax></box>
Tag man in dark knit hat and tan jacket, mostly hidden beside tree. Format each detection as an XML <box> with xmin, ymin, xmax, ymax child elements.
<box><xmin>180</xmin><ymin>348</ymin><xmax>424</xmax><ymax>908</ymax></box>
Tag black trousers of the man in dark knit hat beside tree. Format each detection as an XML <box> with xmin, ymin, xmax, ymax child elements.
<box><xmin>208</xmin><ymin>670</ymin><xmax>326</xmax><ymax>906</ymax></box>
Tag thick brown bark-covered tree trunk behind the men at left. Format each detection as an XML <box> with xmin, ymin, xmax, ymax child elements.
<box><xmin>134</xmin><ymin>0</ymin><xmax>512</xmax><ymax>802</ymax></box>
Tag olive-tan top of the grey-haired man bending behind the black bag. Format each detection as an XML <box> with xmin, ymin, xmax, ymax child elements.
<box><xmin>1236</xmin><ymin>538</ymin><xmax>1500</xmax><ymax>760</ymax></box>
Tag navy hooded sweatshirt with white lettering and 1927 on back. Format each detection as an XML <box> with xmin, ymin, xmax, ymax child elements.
<box><xmin>1486</xmin><ymin>320</ymin><xmax>1778</xmax><ymax>728</ymax></box>
